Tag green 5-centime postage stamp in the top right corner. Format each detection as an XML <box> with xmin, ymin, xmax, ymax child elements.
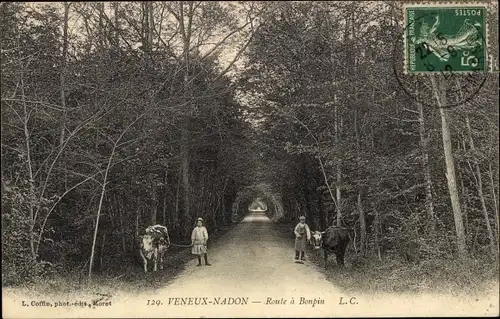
<box><xmin>404</xmin><ymin>3</ymin><xmax>487</xmax><ymax>76</ymax></box>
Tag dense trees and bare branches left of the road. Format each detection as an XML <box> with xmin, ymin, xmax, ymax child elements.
<box><xmin>1</xmin><ymin>3</ymin><xmax>258</xmax><ymax>283</ymax></box>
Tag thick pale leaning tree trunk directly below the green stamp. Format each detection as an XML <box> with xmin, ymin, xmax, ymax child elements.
<box><xmin>430</xmin><ymin>75</ymin><xmax>467</xmax><ymax>259</ymax></box>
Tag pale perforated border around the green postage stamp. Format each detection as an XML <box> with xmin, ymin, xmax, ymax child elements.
<box><xmin>402</xmin><ymin>0</ymin><xmax>492</xmax><ymax>76</ymax></box>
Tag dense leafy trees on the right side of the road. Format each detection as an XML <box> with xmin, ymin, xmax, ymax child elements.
<box><xmin>240</xmin><ymin>2</ymin><xmax>498</xmax><ymax>261</ymax></box>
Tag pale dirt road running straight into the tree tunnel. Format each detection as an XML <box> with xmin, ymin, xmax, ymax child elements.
<box><xmin>146</xmin><ymin>213</ymin><xmax>340</xmax><ymax>317</ymax></box>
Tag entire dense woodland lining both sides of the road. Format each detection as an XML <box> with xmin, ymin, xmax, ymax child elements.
<box><xmin>0</xmin><ymin>1</ymin><xmax>499</xmax><ymax>284</ymax></box>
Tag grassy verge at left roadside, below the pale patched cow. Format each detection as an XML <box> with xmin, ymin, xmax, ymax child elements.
<box><xmin>3</xmin><ymin>225</ymin><xmax>238</xmax><ymax>298</ymax></box>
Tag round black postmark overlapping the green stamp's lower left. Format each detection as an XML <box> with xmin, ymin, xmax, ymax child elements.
<box><xmin>392</xmin><ymin>11</ymin><xmax>488</xmax><ymax>108</ymax></box>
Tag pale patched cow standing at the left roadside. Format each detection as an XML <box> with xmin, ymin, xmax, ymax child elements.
<box><xmin>139</xmin><ymin>225</ymin><xmax>170</xmax><ymax>272</ymax></box>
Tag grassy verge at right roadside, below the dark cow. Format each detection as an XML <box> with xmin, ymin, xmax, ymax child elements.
<box><xmin>277</xmin><ymin>223</ymin><xmax>499</xmax><ymax>296</ymax></box>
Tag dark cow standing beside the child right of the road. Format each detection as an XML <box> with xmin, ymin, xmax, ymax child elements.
<box><xmin>311</xmin><ymin>226</ymin><xmax>349</xmax><ymax>269</ymax></box>
